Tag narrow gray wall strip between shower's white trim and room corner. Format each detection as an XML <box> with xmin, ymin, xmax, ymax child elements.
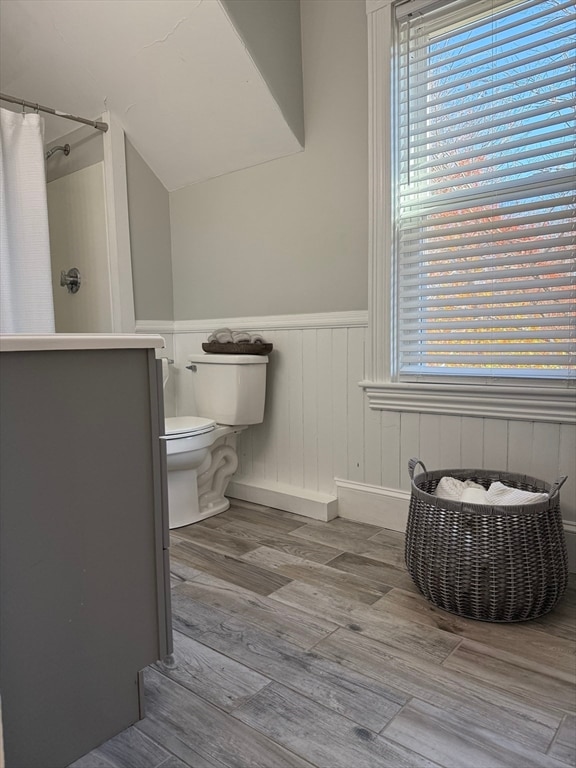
<box><xmin>126</xmin><ymin>139</ymin><xmax>174</xmax><ymax>320</ymax></box>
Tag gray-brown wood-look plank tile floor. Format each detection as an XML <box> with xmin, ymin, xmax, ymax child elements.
<box><xmin>74</xmin><ymin>503</ymin><xmax>576</xmax><ymax>768</ymax></box>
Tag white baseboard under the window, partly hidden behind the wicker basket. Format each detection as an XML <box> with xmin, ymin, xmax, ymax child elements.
<box><xmin>336</xmin><ymin>478</ymin><xmax>576</xmax><ymax>573</ymax></box>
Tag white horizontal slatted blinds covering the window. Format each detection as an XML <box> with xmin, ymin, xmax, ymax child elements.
<box><xmin>394</xmin><ymin>0</ymin><xmax>576</xmax><ymax>380</ymax></box>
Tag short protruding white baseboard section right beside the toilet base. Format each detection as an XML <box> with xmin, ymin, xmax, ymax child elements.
<box><xmin>226</xmin><ymin>480</ymin><xmax>338</xmax><ymax>522</ymax></box>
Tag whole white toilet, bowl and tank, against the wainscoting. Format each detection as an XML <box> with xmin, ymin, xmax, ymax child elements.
<box><xmin>162</xmin><ymin>354</ymin><xmax>268</xmax><ymax>528</ymax></box>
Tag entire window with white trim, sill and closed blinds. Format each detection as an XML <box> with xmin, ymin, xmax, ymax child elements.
<box><xmin>363</xmin><ymin>0</ymin><xmax>576</xmax><ymax>421</ymax></box>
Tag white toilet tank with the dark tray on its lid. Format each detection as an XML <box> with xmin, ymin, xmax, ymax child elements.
<box><xmin>188</xmin><ymin>353</ymin><xmax>268</xmax><ymax>426</ymax></box>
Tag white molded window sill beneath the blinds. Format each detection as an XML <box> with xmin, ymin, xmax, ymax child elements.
<box><xmin>360</xmin><ymin>381</ymin><xmax>576</xmax><ymax>424</ymax></box>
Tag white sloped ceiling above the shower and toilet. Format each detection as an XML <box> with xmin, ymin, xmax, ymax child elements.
<box><xmin>0</xmin><ymin>0</ymin><xmax>302</xmax><ymax>191</ymax></box>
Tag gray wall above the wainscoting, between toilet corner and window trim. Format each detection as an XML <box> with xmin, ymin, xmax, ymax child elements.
<box><xmin>169</xmin><ymin>0</ymin><xmax>368</xmax><ymax>320</ymax></box>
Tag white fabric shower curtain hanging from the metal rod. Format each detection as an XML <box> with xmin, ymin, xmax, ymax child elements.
<box><xmin>0</xmin><ymin>109</ymin><xmax>54</xmax><ymax>334</ymax></box>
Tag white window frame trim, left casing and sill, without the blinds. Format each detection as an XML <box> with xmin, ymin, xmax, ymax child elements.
<box><xmin>360</xmin><ymin>0</ymin><xmax>576</xmax><ymax>423</ymax></box>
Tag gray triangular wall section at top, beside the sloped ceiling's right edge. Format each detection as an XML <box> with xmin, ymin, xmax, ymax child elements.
<box><xmin>222</xmin><ymin>0</ymin><xmax>304</xmax><ymax>145</ymax></box>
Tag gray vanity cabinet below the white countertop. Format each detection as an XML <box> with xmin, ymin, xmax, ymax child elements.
<box><xmin>0</xmin><ymin>348</ymin><xmax>171</xmax><ymax>768</ymax></box>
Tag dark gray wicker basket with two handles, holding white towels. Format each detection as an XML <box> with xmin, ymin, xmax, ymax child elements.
<box><xmin>406</xmin><ymin>459</ymin><xmax>568</xmax><ymax>621</ymax></box>
